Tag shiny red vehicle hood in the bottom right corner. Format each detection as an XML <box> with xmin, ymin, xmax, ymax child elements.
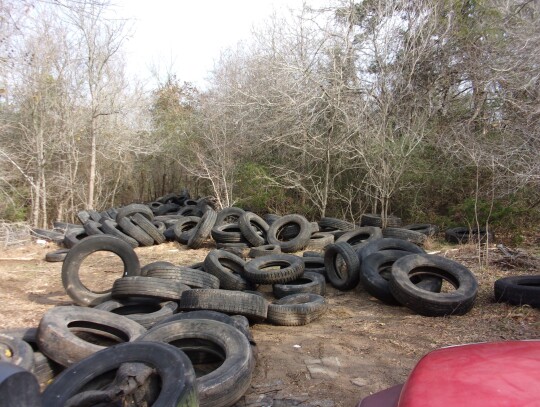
<box><xmin>398</xmin><ymin>340</ymin><xmax>540</xmax><ymax>407</ymax></box>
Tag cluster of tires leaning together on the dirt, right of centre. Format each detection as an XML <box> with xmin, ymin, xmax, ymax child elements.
<box><xmin>324</xmin><ymin>226</ymin><xmax>478</xmax><ymax>316</ymax></box>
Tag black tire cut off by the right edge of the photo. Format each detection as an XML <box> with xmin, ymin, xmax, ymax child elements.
<box><xmin>494</xmin><ymin>276</ymin><xmax>540</xmax><ymax>308</ymax></box>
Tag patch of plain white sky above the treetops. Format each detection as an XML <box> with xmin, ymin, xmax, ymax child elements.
<box><xmin>114</xmin><ymin>0</ymin><xmax>321</xmax><ymax>87</ymax></box>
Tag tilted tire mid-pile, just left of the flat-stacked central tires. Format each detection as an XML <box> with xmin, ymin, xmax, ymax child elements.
<box><xmin>204</xmin><ymin>250</ymin><xmax>252</xmax><ymax>291</ymax></box>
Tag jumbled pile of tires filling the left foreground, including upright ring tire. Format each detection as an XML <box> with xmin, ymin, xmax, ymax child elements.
<box><xmin>0</xmin><ymin>231</ymin><xmax>334</xmax><ymax>407</ymax></box>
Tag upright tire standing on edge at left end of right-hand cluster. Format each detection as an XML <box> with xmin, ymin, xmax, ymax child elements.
<box><xmin>324</xmin><ymin>242</ymin><xmax>360</xmax><ymax>291</ymax></box>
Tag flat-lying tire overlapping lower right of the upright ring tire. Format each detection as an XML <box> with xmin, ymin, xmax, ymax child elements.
<box><xmin>111</xmin><ymin>276</ymin><xmax>190</xmax><ymax>301</ymax></box>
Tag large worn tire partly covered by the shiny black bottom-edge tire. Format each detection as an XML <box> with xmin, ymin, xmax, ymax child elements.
<box><xmin>137</xmin><ymin>319</ymin><xmax>251</xmax><ymax>407</ymax></box>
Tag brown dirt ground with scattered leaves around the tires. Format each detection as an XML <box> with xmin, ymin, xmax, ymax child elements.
<box><xmin>0</xmin><ymin>242</ymin><xmax>540</xmax><ymax>407</ymax></box>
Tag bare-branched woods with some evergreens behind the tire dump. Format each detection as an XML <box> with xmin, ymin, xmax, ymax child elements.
<box><xmin>0</xmin><ymin>0</ymin><xmax>540</xmax><ymax>234</ymax></box>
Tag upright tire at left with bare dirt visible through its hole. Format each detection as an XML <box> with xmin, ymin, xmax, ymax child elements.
<box><xmin>62</xmin><ymin>235</ymin><xmax>141</xmax><ymax>307</ymax></box>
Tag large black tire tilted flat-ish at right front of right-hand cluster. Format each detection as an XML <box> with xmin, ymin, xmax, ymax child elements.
<box><xmin>390</xmin><ymin>254</ymin><xmax>478</xmax><ymax>316</ymax></box>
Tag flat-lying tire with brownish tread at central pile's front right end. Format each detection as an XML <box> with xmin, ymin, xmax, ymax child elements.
<box><xmin>268</xmin><ymin>293</ymin><xmax>327</xmax><ymax>326</ymax></box>
